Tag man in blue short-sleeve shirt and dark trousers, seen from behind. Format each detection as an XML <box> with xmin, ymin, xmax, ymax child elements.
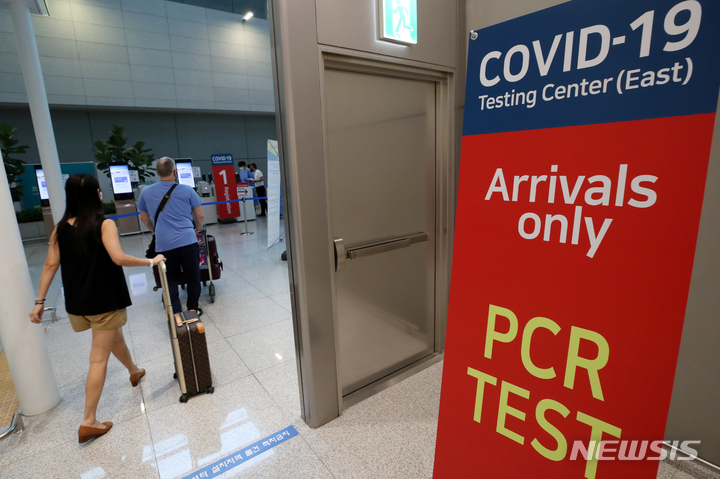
<box><xmin>137</xmin><ymin>157</ymin><xmax>205</xmax><ymax>315</ymax></box>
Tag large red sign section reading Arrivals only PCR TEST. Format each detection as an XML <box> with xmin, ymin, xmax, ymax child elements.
<box><xmin>435</xmin><ymin>114</ymin><xmax>715</xmax><ymax>479</ymax></box>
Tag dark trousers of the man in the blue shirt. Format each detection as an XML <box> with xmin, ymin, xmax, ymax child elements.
<box><xmin>161</xmin><ymin>243</ymin><xmax>200</xmax><ymax>313</ymax></box>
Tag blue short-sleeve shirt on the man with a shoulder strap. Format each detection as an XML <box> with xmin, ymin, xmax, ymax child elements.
<box><xmin>137</xmin><ymin>181</ymin><xmax>202</xmax><ymax>252</ymax></box>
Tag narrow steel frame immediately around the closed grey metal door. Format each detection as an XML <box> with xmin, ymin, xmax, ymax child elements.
<box><xmin>319</xmin><ymin>51</ymin><xmax>455</xmax><ymax>410</ymax></box>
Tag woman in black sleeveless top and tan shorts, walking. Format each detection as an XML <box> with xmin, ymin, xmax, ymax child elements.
<box><xmin>30</xmin><ymin>173</ymin><xmax>165</xmax><ymax>443</ymax></box>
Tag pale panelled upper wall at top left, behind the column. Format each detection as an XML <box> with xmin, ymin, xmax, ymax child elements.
<box><xmin>0</xmin><ymin>0</ymin><xmax>274</xmax><ymax>112</ymax></box>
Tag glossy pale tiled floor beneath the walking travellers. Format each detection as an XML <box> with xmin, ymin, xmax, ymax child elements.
<box><xmin>0</xmin><ymin>219</ymin><xmax>720</xmax><ymax>479</ymax></box>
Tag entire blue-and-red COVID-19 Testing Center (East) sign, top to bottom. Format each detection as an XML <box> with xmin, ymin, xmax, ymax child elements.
<box><xmin>434</xmin><ymin>0</ymin><xmax>720</xmax><ymax>479</ymax></box>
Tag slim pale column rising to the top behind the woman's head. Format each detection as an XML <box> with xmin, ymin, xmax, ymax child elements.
<box><xmin>9</xmin><ymin>3</ymin><xmax>65</xmax><ymax>224</ymax></box>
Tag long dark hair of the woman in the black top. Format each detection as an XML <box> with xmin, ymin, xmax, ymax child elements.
<box><xmin>57</xmin><ymin>173</ymin><xmax>105</xmax><ymax>258</ymax></box>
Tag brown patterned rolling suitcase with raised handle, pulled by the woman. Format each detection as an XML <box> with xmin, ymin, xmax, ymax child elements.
<box><xmin>158</xmin><ymin>262</ymin><xmax>215</xmax><ymax>402</ymax></box>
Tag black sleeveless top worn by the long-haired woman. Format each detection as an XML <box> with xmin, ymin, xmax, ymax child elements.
<box><xmin>58</xmin><ymin>222</ymin><xmax>132</xmax><ymax>316</ymax></box>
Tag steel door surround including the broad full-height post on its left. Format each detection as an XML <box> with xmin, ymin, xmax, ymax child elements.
<box><xmin>268</xmin><ymin>0</ymin><xmax>458</xmax><ymax>427</ymax></box>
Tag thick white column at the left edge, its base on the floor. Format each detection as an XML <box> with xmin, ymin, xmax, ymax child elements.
<box><xmin>0</xmin><ymin>154</ymin><xmax>60</xmax><ymax>416</ymax></box>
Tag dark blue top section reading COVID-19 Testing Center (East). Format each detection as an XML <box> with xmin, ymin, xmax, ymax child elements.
<box><xmin>463</xmin><ymin>0</ymin><xmax>720</xmax><ymax>135</ymax></box>
